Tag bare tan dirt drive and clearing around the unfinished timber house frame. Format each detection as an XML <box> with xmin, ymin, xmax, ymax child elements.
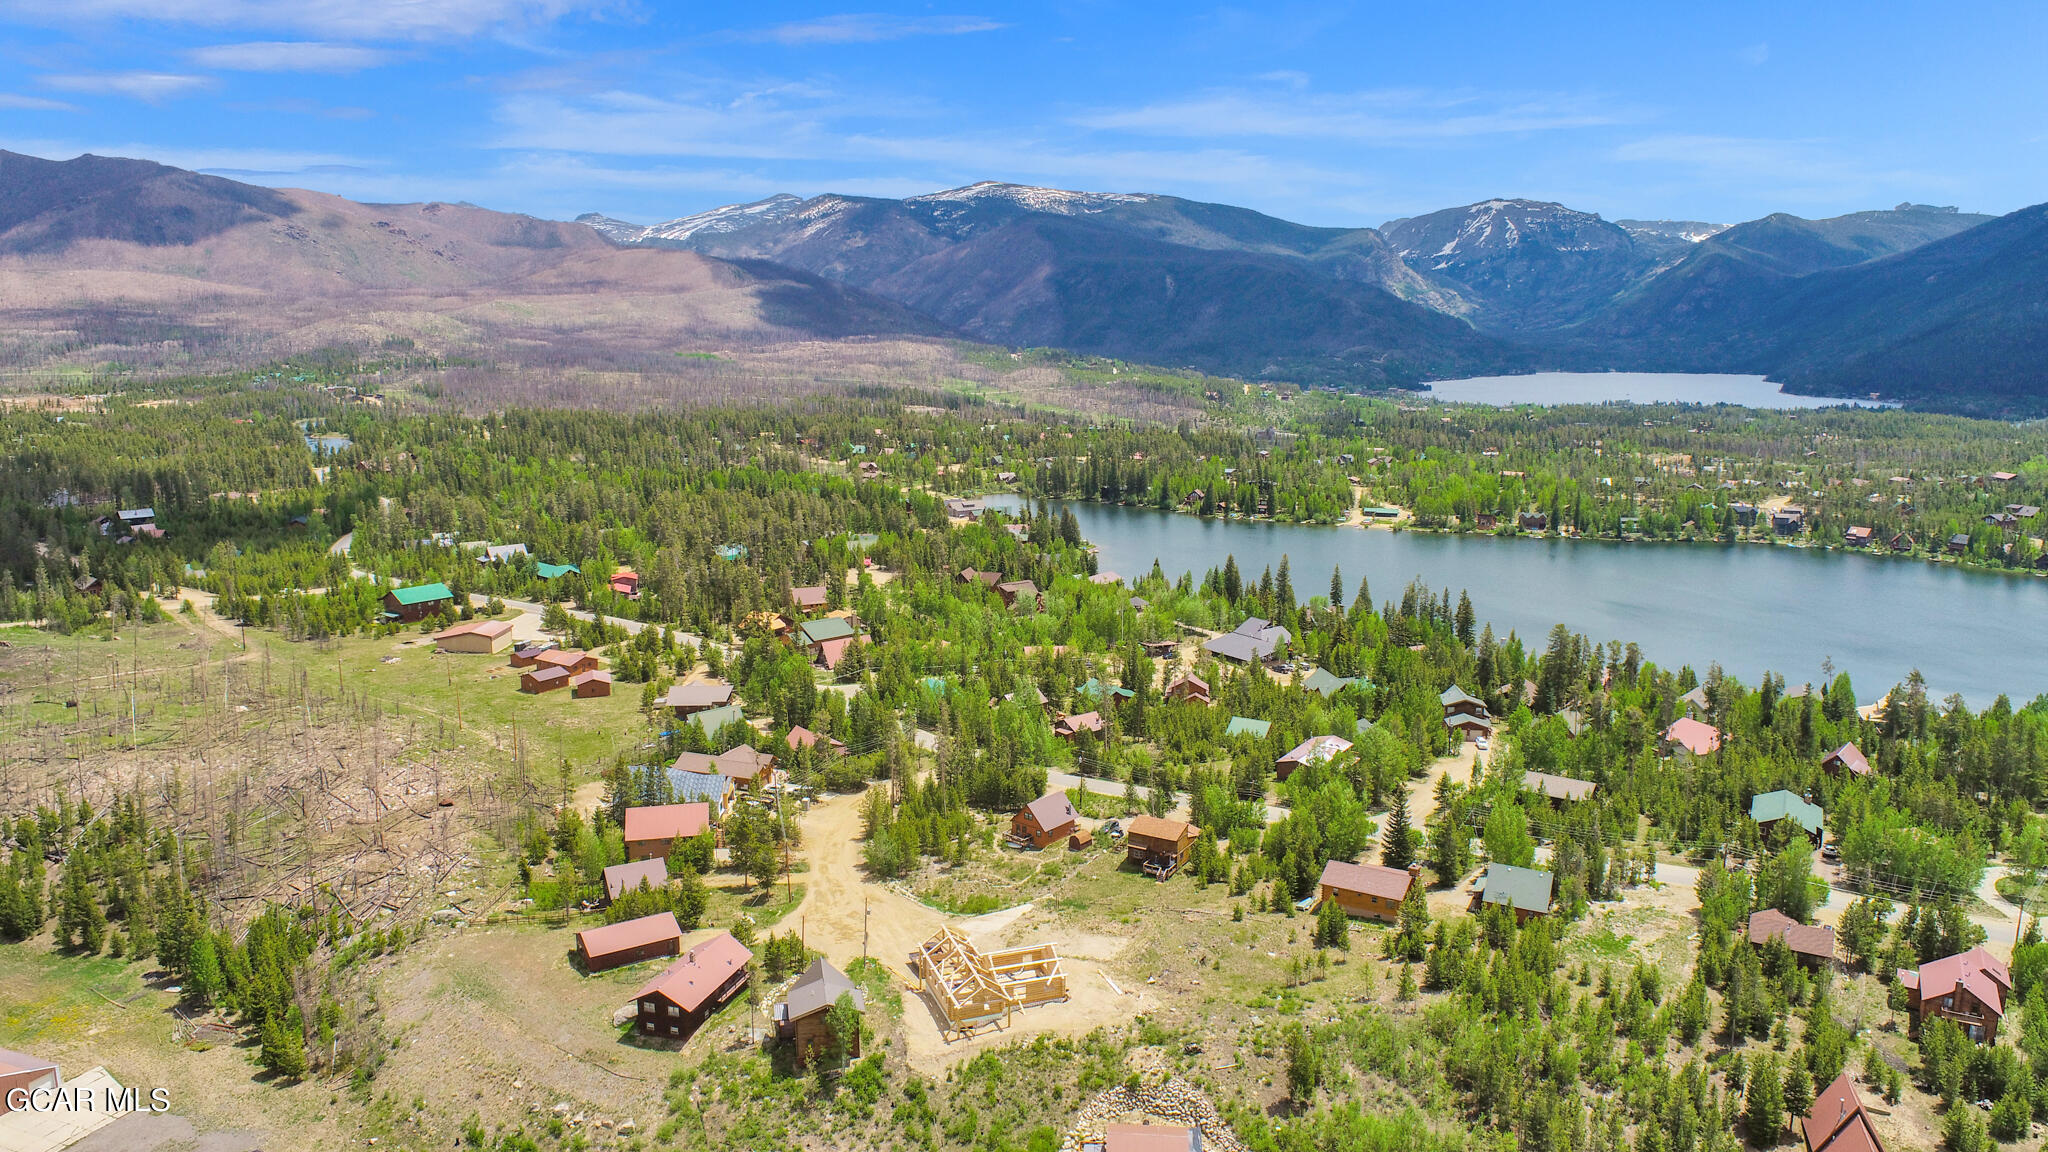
<box><xmin>782</xmin><ymin>795</ymin><xmax>1143</xmax><ymax>1074</ymax></box>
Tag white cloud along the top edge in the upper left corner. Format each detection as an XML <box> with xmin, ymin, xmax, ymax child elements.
<box><xmin>8</xmin><ymin>0</ymin><xmax>618</xmax><ymax>41</ymax></box>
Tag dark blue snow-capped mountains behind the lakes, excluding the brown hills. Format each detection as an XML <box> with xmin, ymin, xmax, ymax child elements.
<box><xmin>580</xmin><ymin>182</ymin><xmax>2048</xmax><ymax>412</ymax></box>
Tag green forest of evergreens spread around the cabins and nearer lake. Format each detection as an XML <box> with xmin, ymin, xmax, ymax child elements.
<box><xmin>0</xmin><ymin>379</ymin><xmax>2048</xmax><ymax>1152</ymax></box>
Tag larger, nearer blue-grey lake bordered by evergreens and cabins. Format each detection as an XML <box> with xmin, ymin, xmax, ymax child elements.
<box><xmin>989</xmin><ymin>498</ymin><xmax>2048</xmax><ymax>707</ymax></box>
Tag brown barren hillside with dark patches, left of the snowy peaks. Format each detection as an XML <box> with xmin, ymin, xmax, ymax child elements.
<box><xmin>0</xmin><ymin>154</ymin><xmax>946</xmax><ymax>389</ymax></box>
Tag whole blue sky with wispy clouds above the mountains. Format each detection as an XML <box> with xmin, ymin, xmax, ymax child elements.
<box><xmin>0</xmin><ymin>0</ymin><xmax>2048</xmax><ymax>225</ymax></box>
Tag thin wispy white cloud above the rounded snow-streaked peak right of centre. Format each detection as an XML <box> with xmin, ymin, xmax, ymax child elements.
<box><xmin>1075</xmin><ymin>86</ymin><xmax>1640</xmax><ymax>143</ymax></box>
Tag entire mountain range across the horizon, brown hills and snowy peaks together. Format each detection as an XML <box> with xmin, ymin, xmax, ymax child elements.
<box><xmin>0</xmin><ymin>152</ymin><xmax>2048</xmax><ymax>416</ymax></box>
